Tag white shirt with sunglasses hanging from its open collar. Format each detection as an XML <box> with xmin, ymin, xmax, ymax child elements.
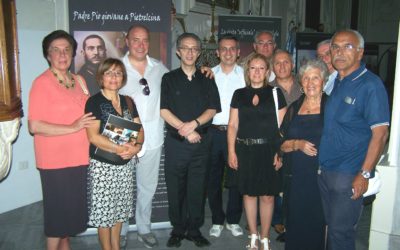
<box><xmin>119</xmin><ymin>52</ymin><xmax>168</xmax><ymax>150</ymax></box>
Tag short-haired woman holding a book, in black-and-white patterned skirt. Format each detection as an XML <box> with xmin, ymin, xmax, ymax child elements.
<box><xmin>85</xmin><ymin>58</ymin><xmax>144</xmax><ymax>249</ymax></box>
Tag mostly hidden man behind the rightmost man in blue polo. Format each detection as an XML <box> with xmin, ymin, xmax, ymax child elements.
<box><xmin>317</xmin><ymin>39</ymin><xmax>337</xmax><ymax>95</ymax></box>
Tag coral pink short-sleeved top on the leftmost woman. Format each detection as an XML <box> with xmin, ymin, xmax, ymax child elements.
<box><xmin>28</xmin><ymin>70</ymin><xmax>89</xmax><ymax>169</ymax></box>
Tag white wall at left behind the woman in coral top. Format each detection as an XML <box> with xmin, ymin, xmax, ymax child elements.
<box><xmin>0</xmin><ymin>0</ymin><xmax>63</xmax><ymax>213</ymax></box>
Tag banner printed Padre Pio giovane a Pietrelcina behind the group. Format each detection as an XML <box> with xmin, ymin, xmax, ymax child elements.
<box><xmin>68</xmin><ymin>0</ymin><xmax>171</xmax><ymax>229</ymax></box>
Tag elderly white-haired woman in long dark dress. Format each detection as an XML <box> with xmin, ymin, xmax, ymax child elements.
<box><xmin>281</xmin><ymin>60</ymin><xmax>329</xmax><ymax>250</ymax></box>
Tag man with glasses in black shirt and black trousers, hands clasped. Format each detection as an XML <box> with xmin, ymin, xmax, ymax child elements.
<box><xmin>160</xmin><ymin>33</ymin><xmax>221</xmax><ymax>247</ymax></box>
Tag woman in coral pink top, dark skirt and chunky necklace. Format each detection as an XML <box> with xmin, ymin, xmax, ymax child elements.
<box><xmin>28</xmin><ymin>30</ymin><xmax>94</xmax><ymax>249</ymax></box>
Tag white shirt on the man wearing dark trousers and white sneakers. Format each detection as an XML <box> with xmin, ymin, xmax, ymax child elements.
<box><xmin>212</xmin><ymin>64</ymin><xmax>246</xmax><ymax>125</ymax></box>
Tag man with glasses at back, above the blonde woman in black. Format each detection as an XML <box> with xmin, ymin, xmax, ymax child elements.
<box><xmin>239</xmin><ymin>30</ymin><xmax>276</xmax><ymax>82</ymax></box>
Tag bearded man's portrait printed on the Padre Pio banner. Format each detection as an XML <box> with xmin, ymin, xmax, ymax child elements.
<box><xmin>78</xmin><ymin>34</ymin><xmax>107</xmax><ymax>95</ymax></box>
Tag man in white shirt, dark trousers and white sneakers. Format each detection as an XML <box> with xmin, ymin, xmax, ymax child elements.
<box><xmin>207</xmin><ymin>36</ymin><xmax>246</xmax><ymax>237</ymax></box>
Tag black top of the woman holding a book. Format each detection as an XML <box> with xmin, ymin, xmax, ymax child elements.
<box><xmin>85</xmin><ymin>93</ymin><xmax>139</xmax><ymax>164</ymax></box>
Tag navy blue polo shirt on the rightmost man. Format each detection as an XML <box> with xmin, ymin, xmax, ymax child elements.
<box><xmin>319</xmin><ymin>64</ymin><xmax>390</xmax><ymax>174</ymax></box>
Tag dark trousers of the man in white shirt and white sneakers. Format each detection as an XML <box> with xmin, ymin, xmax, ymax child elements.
<box><xmin>207</xmin><ymin>128</ymin><xmax>243</xmax><ymax>225</ymax></box>
